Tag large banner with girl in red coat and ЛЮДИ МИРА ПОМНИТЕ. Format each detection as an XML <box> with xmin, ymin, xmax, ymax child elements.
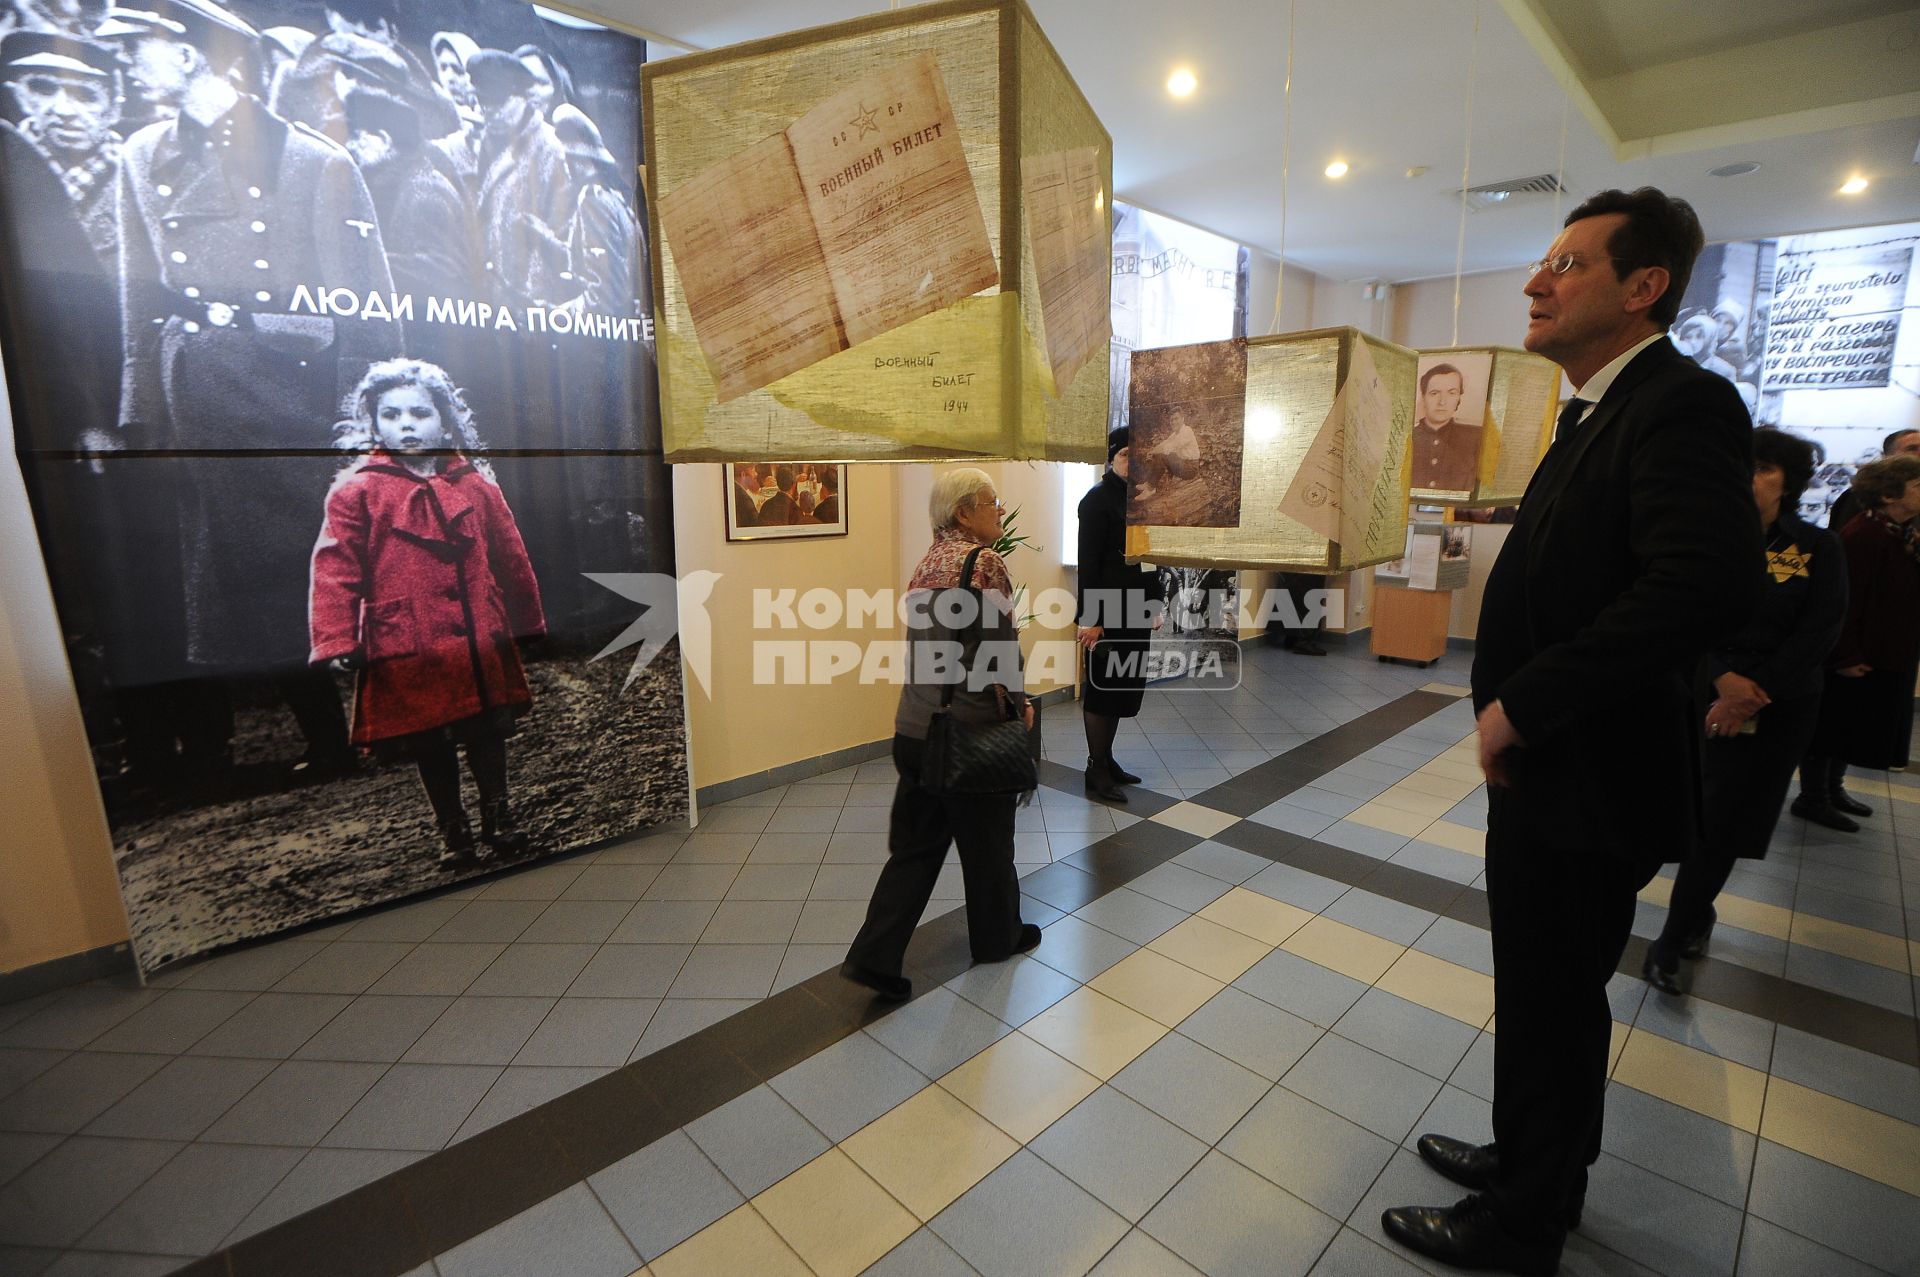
<box><xmin>0</xmin><ymin>0</ymin><xmax>687</xmax><ymax>968</ymax></box>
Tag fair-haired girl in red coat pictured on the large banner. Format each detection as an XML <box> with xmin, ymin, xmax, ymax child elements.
<box><xmin>307</xmin><ymin>359</ymin><xmax>547</xmax><ymax>864</ymax></box>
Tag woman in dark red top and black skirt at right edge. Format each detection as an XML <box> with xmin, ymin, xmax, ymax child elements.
<box><xmin>1791</xmin><ymin>455</ymin><xmax>1920</xmax><ymax>833</ymax></box>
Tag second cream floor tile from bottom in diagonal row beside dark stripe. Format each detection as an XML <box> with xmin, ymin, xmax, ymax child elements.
<box><xmin>753</xmin><ymin>1148</ymin><xmax>920</xmax><ymax>1277</ymax></box>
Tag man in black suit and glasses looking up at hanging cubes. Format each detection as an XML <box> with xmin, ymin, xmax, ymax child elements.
<box><xmin>1380</xmin><ymin>188</ymin><xmax>1763</xmax><ymax>1273</ymax></box>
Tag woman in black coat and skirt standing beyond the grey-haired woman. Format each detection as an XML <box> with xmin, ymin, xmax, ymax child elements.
<box><xmin>1077</xmin><ymin>426</ymin><xmax>1160</xmax><ymax>803</ymax></box>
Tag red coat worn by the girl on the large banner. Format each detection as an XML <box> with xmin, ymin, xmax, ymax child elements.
<box><xmin>307</xmin><ymin>451</ymin><xmax>547</xmax><ymax>745</ymax></box>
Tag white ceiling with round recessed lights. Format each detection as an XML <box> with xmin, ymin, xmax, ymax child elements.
<box><xmin>574</xmin><ymin>0</ymin><xmax>1920</xmax><ymax>280</ymax></box>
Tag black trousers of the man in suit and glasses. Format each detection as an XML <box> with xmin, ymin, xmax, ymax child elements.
<box><xmin>1486</xmin><ymin>787</ymin><xmax>1653</xmax><ymax>1241</ymax></box>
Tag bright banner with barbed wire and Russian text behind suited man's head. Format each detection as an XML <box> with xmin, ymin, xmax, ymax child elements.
<box><xmin>1672</xmin><ymin>223</ymin><xmax>1920</xmax><ymax>524</ymax></box>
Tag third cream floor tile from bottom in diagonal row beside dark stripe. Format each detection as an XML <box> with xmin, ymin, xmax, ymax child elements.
<box><xmin>840</xmin><ymin>1087</ymin><xmax>1020</xmax><ymax>1221</ymax></box>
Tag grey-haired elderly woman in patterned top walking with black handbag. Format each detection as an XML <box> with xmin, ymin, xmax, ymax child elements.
<box><xmin>841</xmin><ymin>467</ymin><xmax>1041</xmax><ymax>1000</ymax></box>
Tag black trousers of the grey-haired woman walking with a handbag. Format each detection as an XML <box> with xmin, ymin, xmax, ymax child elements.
<box><xmin>847</xmin><ymin>735</ymin><xmax>1020</xmax><ymax>976</ymax></box>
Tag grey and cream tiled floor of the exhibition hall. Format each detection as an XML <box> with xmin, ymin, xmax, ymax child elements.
<box><xmin>0</xmin><ymin>651</ymin><xmax>1920</xmax><ymax>1277</ymax></box>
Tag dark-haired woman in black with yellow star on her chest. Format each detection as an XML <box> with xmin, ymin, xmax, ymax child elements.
<box><xmin>1642</xmin><ymin>430</ymin><xmax>1847</xmax><ymax>993</ymax></box>
